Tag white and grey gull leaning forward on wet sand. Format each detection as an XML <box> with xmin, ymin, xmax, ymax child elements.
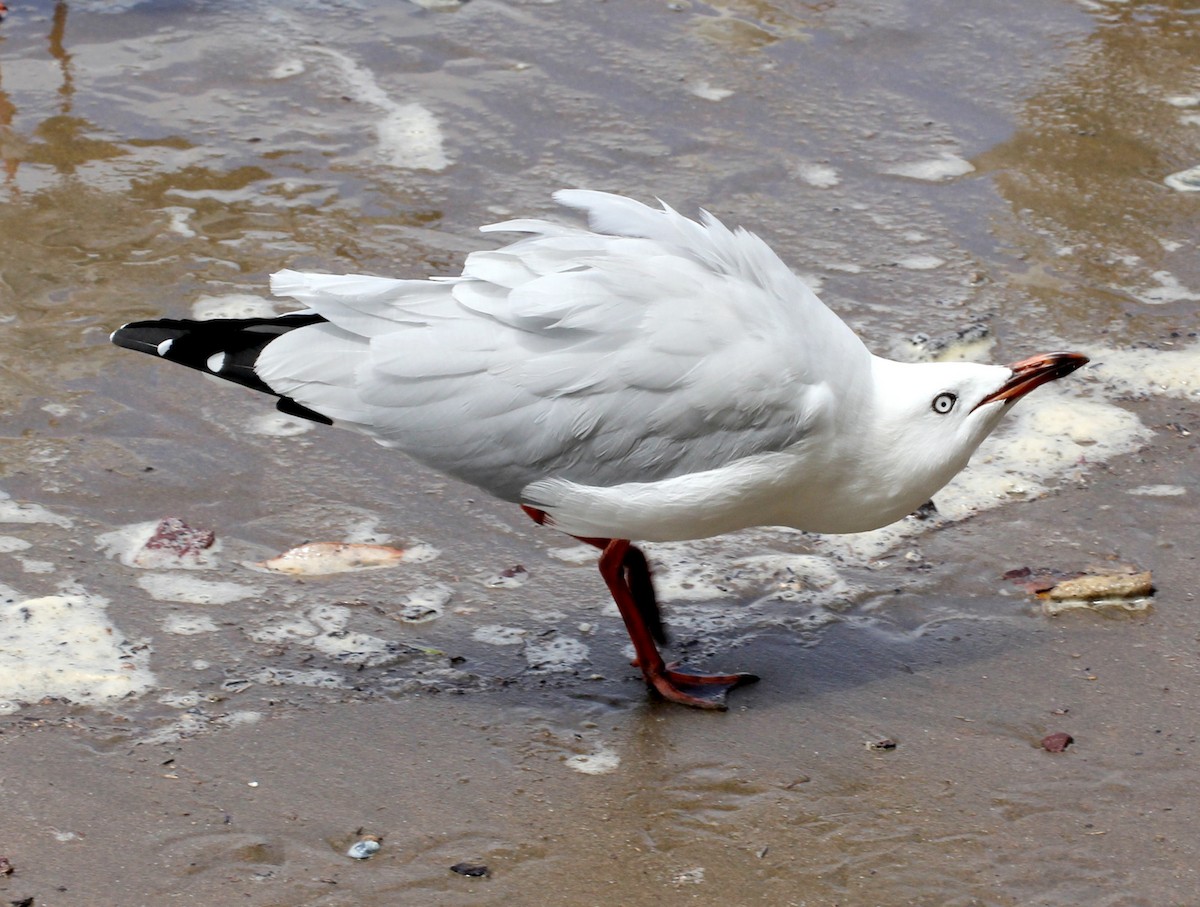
<box><xmin>112</xmin><ymin>190</ymin><xmax>1087</xmax><ymax>709</ymax></box>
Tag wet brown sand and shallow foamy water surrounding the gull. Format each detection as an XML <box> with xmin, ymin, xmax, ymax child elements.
<box><xmin>0</xmin><ymin>0</ymin><xmax>1200</xmax><ymax>905</ymax></box>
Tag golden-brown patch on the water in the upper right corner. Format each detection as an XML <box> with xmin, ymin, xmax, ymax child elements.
<box><xmin>978</xmin><ymin>2</ymin><xmax>1200</xmax><ymax>326</ymax></box>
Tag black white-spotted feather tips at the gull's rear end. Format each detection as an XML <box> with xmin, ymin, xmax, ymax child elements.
<box><xmin>109</xmin><ymin>312</ymin><xmax>332</xmax><ymax>425</ymax></box>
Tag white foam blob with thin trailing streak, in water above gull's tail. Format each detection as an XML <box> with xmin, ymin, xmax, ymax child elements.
<box><xmin>307</xmin><ymin>47</ymin><xmax>450</xmax><ymax>170</ymax></box>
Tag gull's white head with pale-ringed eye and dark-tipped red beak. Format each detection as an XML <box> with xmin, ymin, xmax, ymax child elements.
<box><xmin>865</xmin><ymin>353</ymin><xmax>1087</xmax><ymax>505</ymax></box>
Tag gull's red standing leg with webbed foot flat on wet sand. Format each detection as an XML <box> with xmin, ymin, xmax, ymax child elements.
<box><xmin>600</xmin><ymin>539</ymin><xmax>758</xmax><ymax>709</ymax></box>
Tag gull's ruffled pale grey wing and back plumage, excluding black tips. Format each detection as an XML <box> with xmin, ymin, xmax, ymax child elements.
<box><xmin>257</xmin><ymin>190</ymin><xmax>869</xmax><ymax>500</ymax></box>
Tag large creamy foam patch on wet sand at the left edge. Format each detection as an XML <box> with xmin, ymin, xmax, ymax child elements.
<box><xmin>0</xmin><ymin>594</ymin><xmax>155</xmax><ymax>703</ymax></box>
